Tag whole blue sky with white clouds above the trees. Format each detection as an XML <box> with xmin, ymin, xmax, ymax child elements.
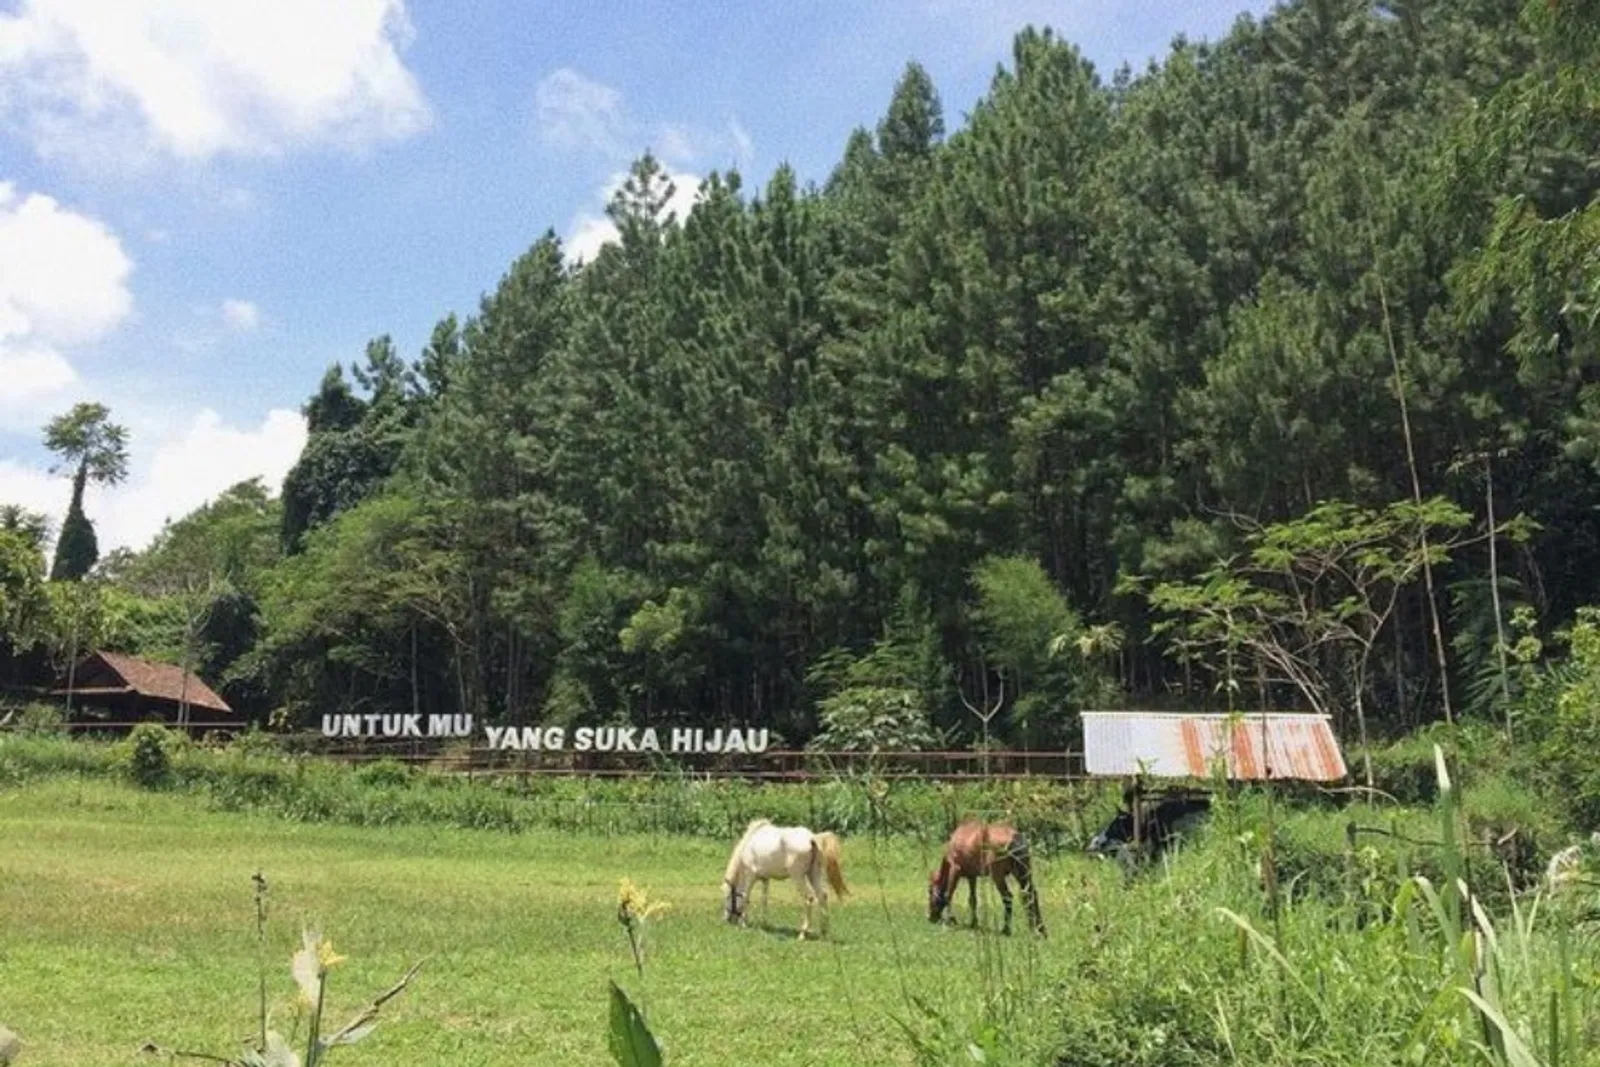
<box><xmin>0</xmin><ymin>0</ymin><xmax>1270</xmax><ymax>553</ymax></box>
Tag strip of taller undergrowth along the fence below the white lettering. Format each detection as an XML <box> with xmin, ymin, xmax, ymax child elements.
<box><xmin>0</xmin><ymin>725</ymin><xmax>1117</xmax><ymax>848</ymax></box>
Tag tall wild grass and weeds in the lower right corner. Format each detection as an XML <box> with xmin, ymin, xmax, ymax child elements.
<box><xmin>907</xmin><ymin>750</ymin><xmax>1600</xmax><ymax>1067</ymax></box>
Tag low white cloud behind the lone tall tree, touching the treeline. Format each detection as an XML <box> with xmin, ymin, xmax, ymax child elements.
<box><xmin>0</xmin><ymin>408</ymin><xmax>306</xmax><ymax>555</ymax></box>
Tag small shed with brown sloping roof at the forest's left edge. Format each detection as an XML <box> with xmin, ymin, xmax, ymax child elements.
<box><xmin>51</xmin><ymin>651</ymin><xmax>234</xmax><ymax>725</ymax></box>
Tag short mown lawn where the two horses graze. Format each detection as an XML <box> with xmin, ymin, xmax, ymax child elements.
<box><xmin>0</xmin><ymin>779</ymin><xmax>1088</xmax><ymax>1067</ymax></box>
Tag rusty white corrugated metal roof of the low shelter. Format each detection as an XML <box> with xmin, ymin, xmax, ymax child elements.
<box><xmin>1083</xmin><ymin>712</ymin><xmax>1347</xmax><ymax>782</ymax></box>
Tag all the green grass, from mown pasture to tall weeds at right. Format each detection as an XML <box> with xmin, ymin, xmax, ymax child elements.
<box><xmin>0</xmin><ymin>744</ymin><xmax>1600</xmax><ymax>1067</ymax></box>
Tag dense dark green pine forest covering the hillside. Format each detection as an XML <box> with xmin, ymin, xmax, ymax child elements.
<box><xmin>6</xmin><ymin>0</ymin><xmax>1600</xmax><ymax>749</ymax></box>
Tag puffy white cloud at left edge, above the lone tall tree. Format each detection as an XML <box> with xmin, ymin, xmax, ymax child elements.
<box><xmin>0</xmin><ymin>182</ymin><xmax>133</xmax><ymax>434</ymax></box>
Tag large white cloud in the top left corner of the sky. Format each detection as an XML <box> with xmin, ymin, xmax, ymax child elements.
<box><xmin>0</xmin><ymin>0</ymin><xmax>432</xmax><ymax>160</ymax></box>
